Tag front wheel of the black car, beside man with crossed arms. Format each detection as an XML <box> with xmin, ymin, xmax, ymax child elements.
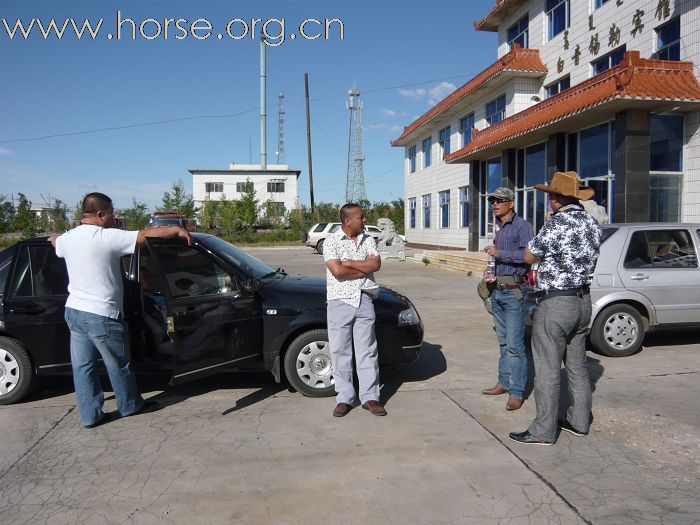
<box><xmin>284</xmin><ymin>329</ymin><xmax>335</xmax><ymax>397</ymax></box>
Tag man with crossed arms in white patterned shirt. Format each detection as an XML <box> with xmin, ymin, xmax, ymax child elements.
<box><xmin>323</xmin><ymin>204</ymin><xmax>386</xmax><ymax>417</ymax></box>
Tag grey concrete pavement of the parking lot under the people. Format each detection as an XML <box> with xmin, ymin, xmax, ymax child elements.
<box><xmin>0</xmin><ymin>247</ymin><xmax>700</xmax><ymax>525</ymax></box>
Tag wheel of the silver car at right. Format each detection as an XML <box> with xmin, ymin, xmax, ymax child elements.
<box><xmin>591</xmin><ymin>304</ymin><xmax>646</xmax><ymax>357</ymax></box>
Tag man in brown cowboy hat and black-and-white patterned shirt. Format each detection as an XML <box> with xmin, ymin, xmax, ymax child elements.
<box><xmin>508</xmin><ymin>171</ymin><xmax>602</xmax><ymax>445</ymax></box>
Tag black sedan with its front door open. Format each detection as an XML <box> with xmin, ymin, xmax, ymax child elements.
<box><xmin>0</xmin><ymin>234</ymin><xmax>423</xmax><ymax>405</ymax></box>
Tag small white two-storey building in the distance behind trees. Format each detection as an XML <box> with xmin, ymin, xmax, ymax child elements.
<box><xmin>189</xmin><ymin>164</ymin><xmax>301</xmax><ymax>216</ymax></box>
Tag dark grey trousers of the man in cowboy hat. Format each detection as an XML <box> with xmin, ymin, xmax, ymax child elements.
<box><xmin>528</xmin><ymin>295</ymin><xmax>592</xmax><ymax>441</ymax></box>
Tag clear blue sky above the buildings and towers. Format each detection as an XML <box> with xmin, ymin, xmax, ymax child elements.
<box><xmin>0</xmin><ymin>0</ymin><xmax>496</xmax><ymax>213</ymax></box>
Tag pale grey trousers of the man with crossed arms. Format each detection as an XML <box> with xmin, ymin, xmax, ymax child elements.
<box><xmin>328</xmin><ymin>293</ymin><xmax>379</xmax><ymax>405</ymax></box>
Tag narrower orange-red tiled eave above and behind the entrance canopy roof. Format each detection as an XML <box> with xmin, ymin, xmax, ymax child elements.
<box><xmin>391</xmin><ymin>44</ymin><xmax>548</xmax><ymax>146</ymax></box>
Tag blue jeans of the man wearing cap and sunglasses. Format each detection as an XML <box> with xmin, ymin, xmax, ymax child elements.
<box><xmin>491</xmin><ymin>287</ymin><xmax>527</xmax><ymax>399</ymax></box>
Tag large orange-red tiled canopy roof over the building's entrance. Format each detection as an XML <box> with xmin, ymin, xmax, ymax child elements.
<box><xmin>445</xmin><ymin>51</ymin><xmax>700</xmax><ymax>163</ymax></box>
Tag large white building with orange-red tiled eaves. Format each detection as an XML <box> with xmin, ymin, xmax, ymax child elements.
<box><xmin>392</xmin><ymin>0</ymin><xmax>700</xmax><ymax>250</ymax></box>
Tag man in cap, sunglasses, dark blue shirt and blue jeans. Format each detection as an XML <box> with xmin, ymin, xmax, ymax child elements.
<box><xmin>481</xmin><ymin>188</ymin><xmax>532</xmax><ymax>410</ymax></box>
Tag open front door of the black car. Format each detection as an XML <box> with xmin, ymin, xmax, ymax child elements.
<box><xmin>145</xmin><ymin>239</ymin><xmax>261</xmax><ymax>384</ymax></box>
